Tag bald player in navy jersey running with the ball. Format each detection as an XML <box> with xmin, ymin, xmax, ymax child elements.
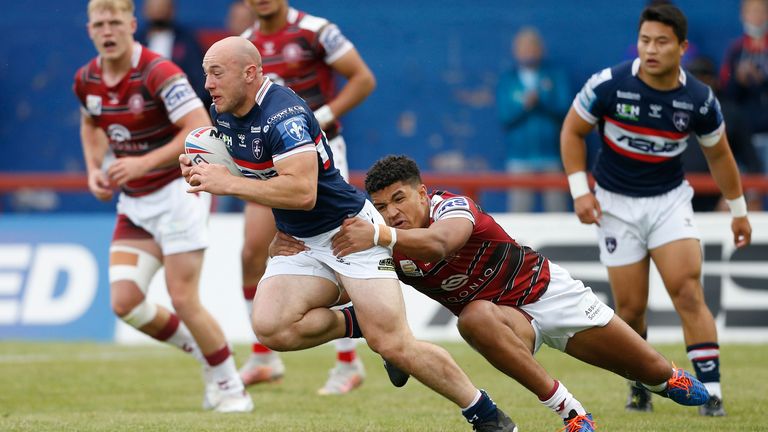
<box><xmin>179</xmin><ymin>37</ymin><xmax>517</xmax><ymax>432</ymax></box>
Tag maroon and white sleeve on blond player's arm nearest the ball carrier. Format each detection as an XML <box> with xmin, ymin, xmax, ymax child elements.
<box><xmin>146</xmin><ymin>59</ymin><xmax>203</xmax><ymax>123</ymax></box>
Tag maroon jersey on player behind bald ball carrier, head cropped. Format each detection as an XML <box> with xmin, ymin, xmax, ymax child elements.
<box><xmin>242</xmin><ymin>8</ymin><xmax>354</xmax><ymax>139</ymax></box>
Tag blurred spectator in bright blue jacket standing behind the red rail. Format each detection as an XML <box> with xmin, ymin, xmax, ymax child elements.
<box><xmin>496</xmin><ymin>27</ymin><xmax>573</xmax><ymax>212</ymax></box>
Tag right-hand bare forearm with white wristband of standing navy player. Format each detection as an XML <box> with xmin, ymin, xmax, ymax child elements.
<box><xmin>701</xmin><ymin>132</ymin><xmax>752</xmax><ymax>248</ymax></box>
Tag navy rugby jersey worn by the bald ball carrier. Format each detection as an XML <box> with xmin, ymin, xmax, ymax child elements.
<box><xmin>211</xmin><ymin>77</ymin><xmax>365</xmax><ymax>237</ymax></box>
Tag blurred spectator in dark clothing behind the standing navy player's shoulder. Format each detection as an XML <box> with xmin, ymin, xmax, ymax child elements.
<box><xmin>682</xmin><ymin>56</ymin><xmax>763</xmax><ymax>212</ymax></box>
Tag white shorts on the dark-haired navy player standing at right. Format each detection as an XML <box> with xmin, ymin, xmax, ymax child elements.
<box><xmin>595</xmin><ymin>181</ymin><xmax>701</xmax><ymax>267</ymax></box>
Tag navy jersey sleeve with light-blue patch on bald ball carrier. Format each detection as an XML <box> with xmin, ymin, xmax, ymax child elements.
<box><xmin>267</xmin><ymin>106</ymin><xmax>315</xmax><ymax>161</ymax></box>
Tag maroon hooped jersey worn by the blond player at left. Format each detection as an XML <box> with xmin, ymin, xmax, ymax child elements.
<box><xmin>74</xmin><ymin>43</ymin><xmax>203</xmax><ymax>196</ymax></box>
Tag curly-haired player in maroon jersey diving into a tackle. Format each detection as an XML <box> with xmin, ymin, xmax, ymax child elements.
<box><xmin>270</xmin><ymin>156</ymin><xmax>708</xmax><ymax>431</ymax></box>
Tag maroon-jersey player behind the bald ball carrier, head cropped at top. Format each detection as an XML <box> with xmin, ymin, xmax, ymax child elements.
<box><xmin>240</xmin><ymin>0</ymin><xmax>376</xmax><ymax>394</ymax></box>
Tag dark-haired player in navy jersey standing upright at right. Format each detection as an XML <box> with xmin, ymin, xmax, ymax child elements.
<box><xmin>561</xmin><ymin>5</ymin><xmax>752</xmax><ymax>416</ymax></box>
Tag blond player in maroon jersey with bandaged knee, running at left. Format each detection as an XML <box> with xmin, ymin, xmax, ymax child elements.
<box><xmin>74</xmin><ymin>0</ymin><xmax>253</xmax><ymax>412</ymax></box>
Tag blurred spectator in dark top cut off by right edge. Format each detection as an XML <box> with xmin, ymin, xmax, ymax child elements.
<box><xmin>720</xmin><ymin>0</ymin><xmax>768</xmax><ymax>170</ymax></box>
